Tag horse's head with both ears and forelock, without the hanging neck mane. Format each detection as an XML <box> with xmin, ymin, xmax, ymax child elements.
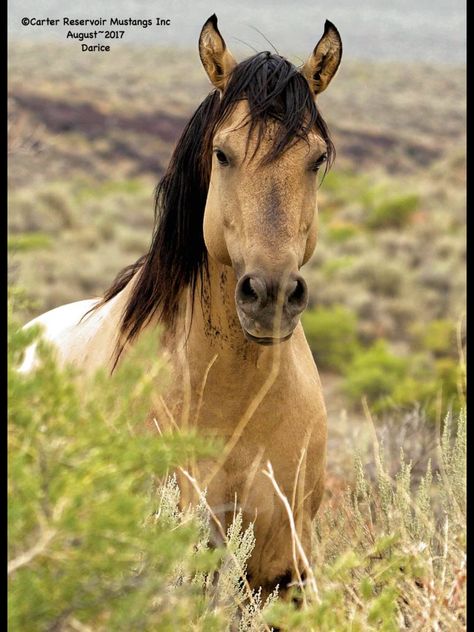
<box><xmin>199</xmin><ymin>16</ymin><xmax>342</xmax><ymax>344</ymax></box>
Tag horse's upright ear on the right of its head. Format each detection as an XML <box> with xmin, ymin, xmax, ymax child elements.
<box><xmin>301</xmin><ymin>20</ymin><xmax>342</xmax><ymax>96</ymax></box>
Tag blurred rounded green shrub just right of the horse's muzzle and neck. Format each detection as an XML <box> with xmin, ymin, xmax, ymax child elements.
<box><xmin>302</xmin><ymin>305</ymin><xmax>357</xmax><ymax>371</ymax></box>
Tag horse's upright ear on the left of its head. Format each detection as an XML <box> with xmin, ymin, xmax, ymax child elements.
<box><xmin>199</xmin><ymin>13</ymin><xmax>237</xmax><ymax>91</ymax></box>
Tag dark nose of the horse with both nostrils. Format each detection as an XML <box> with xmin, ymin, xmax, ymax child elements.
<box><xmin>235</xmin><ymin>274</ymin><xmax>308</xmax><ymax>318</ymax></box>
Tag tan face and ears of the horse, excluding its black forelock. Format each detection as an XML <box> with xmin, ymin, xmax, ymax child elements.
<box><xmin>200</xmin><ymin>13</ymin><xmax>342</xmax><ymax>344</ymax></box>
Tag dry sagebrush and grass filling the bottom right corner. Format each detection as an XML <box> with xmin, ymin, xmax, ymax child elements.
<box><xmin>266</xmin><ymin>412</ymin><xmax>466</xmax><ymax>632</ymax></box>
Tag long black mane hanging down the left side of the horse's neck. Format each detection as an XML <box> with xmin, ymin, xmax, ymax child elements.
<box><xmin>104</xmin><ymin>92</ymin><xmax>219</xmax><ymax>348</ymax></box>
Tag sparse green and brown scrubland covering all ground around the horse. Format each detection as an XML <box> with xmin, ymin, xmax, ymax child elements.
<box><xmin>8</xmin><ymin>42</ymin><xmax>466</xmax><ymax>632</ymax></box>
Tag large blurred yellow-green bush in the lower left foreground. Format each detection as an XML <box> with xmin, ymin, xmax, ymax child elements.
<box><xmin>8</xmin><ymin>312</ymin><xmax>222</xmax><ymax>630</ymax></box>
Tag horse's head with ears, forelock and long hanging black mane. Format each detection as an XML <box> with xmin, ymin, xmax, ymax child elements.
<box><xmin>101</xmin><ymin>16</ymin><xmax>342</xmax><ymax>358</ymax></box>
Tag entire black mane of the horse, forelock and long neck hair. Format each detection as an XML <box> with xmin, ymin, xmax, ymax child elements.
<box><xmin>97</xmin><ymin>52</ymin><xmax>334</xmax><ymax>354</ymax></box>
